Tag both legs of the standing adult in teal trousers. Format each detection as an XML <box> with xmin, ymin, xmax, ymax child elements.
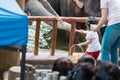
<box><xmin>102</xmin><ymin>24</ymin><xmax>120</xmax><ymax>64</ymax></box>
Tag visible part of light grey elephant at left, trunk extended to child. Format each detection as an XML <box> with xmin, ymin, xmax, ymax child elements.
<box><xmin>25</xmin><ymin>0</ymin><xmax>71</xmax><ymax>31</ymax></box>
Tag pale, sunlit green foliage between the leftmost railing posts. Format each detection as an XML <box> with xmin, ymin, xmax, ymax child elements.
<box><xmin>27</xmin><ymin>22</ymin><xmax>52</xmax><ymax>50</ymax></box>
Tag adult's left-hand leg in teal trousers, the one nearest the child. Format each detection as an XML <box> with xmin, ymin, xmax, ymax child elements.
<box><xmin>101</xmin><ymin>25</ymin><xmax>116</xmax><ymax>62</ymax></box>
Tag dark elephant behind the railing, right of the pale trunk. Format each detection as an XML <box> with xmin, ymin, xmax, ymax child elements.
<box><xmin>44</xmin><ymin>0</ymin><xmax>101</xmax><ymax>43</ymax></box>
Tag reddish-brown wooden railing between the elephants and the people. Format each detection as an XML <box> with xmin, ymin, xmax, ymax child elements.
<box><xmin>28</xmin><ymin>16</ymin><xmax>100</xmax><ymax>55</ymax></box>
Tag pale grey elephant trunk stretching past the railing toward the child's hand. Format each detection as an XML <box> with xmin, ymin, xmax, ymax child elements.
<box><xmin>25</xmin><ymin>0</ymin><xmax>71</xmax><ymax>31</ymax></box>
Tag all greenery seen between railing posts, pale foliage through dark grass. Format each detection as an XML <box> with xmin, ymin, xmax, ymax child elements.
<box><xmin>27</xmin><ymin>22</ymin><xmax>86</xmax><ymax>52</ymax></box>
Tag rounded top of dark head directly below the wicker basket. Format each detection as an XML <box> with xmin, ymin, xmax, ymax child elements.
<box><xmin>78</xmin><ymin>54</ymin><xmax>96</xmax><ymax>65</ymax></box>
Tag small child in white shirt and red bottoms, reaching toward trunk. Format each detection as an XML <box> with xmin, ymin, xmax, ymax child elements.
<box><xmin>75</xmin><ymin>17</ymin><xmax>101</xmax><ymax>60</ymax></box>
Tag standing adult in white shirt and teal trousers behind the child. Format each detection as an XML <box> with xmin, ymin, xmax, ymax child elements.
<box><xmin>93</xmin><ymin>0</ymin><xmax>120</xmax><ymax>64</ymax></box>
